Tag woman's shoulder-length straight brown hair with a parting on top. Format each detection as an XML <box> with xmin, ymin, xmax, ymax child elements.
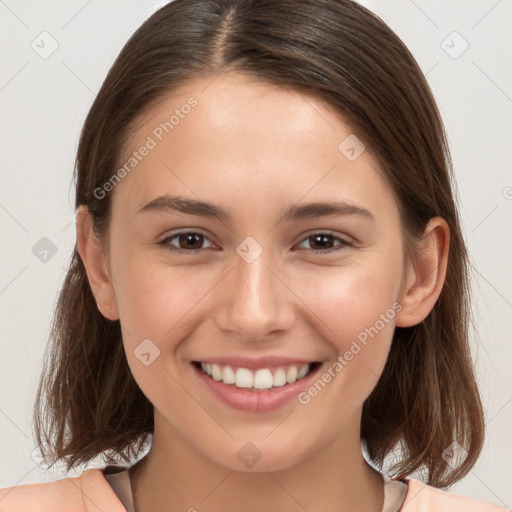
<box><xmin>34</xmin><ymin>0</ymin><xmax>484</xmax><ymax>486</ymax></box>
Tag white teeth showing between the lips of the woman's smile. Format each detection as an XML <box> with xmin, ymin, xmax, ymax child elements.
<box><xmin>192</xmin><ymin>361</ymin><xmax>321</xmax><ymax>392</ymax></box>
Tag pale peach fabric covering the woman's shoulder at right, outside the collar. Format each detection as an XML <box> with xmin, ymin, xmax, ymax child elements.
<box><xmin>400</xmin><ymin>478</ymin><xmax>509</xmax><ymax>512</ymax></box>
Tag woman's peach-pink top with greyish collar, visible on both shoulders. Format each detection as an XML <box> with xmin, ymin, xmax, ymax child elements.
<box><xmin>0</xmin><ymin>468</ymin><xmax>510</xmax><ymax>512</ymax></box>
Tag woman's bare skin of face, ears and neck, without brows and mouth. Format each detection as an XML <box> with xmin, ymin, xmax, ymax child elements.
<box><xmin>77</xmin><ymin>73</ymin><xmax>449</xmax><ymax>512</ymax></box>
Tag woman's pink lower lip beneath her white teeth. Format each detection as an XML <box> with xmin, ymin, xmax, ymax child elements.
<box><xmin>192</xmin><ymin>365</ymin><xmax>321</xmax><ymax>412</ymax></box>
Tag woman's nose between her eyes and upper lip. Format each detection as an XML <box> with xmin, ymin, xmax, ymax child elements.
<box><xmin>214</xmin><ymin>246</ymin><xmax>296</xmax><ymax>342</ymax></box>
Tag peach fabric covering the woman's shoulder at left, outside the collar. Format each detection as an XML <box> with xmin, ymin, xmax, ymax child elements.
<box><xmin>0</xmin><ymin>469</ymin><xmax>126</xmax><ymax>512</ymax></box>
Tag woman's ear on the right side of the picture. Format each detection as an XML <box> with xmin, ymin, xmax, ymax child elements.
<box><xmin>396</xmin><ymin>217</ymin><xmax>450</xmax><ymax>327</ymax></box>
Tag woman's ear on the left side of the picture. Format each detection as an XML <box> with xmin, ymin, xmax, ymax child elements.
<box><xmin>76</xmin><ymin>205</ymin><xmax>119</xmax><ymax>320</ymax></box>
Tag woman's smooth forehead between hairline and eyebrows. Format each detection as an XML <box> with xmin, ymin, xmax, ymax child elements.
<box><xmin>108</xmin><ymin>73</ymin><xmax>396</xmax><ymax>222</ymax></box>
